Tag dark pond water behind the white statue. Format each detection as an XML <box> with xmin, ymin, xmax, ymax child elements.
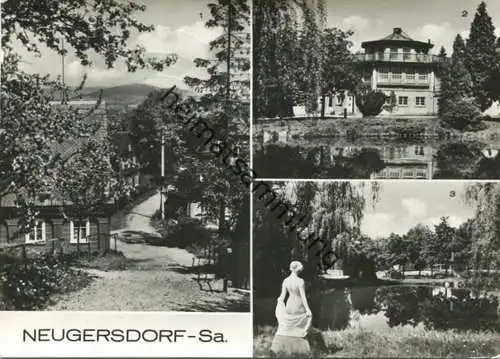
<box><xmin>254</xmin><ymin>285</ymin><xmax>500</xmax><ymax>332</ymax></box>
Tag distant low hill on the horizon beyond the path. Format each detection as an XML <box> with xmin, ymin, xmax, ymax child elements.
<box><xmin>70</xmin><ymin>84</ymin><xmax>195</xmax><ymax>108</ymax></box>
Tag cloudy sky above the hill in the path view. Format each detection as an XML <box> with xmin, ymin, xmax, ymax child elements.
<box><xmin>13</xmin><ymin>0</ymin><xmax>220</xmax><ymax>88</ymax></box>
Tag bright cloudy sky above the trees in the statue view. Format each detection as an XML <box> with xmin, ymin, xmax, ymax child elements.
<box><xmin>361</xmin><ymin>181</ymin><xmax>474</xmax><ymax>238</ymax></box>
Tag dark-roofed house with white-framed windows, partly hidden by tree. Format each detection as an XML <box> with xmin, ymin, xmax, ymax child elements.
<box><xmin>0</xmin><ymin>100</ymin><xmax>114</xmax><ymax>252</ymax></box>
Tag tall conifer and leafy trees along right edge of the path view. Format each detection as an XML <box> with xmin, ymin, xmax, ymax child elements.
<box><xmin>128</xmin><ymin>0</ymin><xmax>250</xmax><ymax>286</ymax></box>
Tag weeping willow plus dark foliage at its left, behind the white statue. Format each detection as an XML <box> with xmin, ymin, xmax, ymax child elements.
<box><xmin>253</xmin><ymin>181</ymin><xmax>380</xmax><ymax>297</ymax></box>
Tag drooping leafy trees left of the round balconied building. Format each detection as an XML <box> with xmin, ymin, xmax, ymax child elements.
<box><xmin>253</xmin><ymin>0</ymin><xmax>361</xmax><ymax>117</ymax></box>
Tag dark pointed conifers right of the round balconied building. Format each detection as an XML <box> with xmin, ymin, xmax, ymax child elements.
<box><xmin>439</xmin><ymin>2</ymin><xmax>500</xmax><ymax>130</ymax></box>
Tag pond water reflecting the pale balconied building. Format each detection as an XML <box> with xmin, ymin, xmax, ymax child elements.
<box><xmin>253</xmin><ymin>134</ymin><xmax>500</xmax><ymax>179</ymax></box>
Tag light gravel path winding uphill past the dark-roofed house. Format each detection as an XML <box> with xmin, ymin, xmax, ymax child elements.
<box><xmin>48</xmin><ymin>193</ymin><xmax>250</xmax><ymax>312</ymax></box>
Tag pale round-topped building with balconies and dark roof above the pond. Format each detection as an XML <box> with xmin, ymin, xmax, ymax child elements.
<box><xmin>326</xmin><ymin>27</ymin><xmax>445</xmax><ymax>116</ymax></box>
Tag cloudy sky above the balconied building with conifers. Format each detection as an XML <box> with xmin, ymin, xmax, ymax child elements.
<box><xmin>326</xmin><ymin>0</ymin><xmax>500</xmax><ymax>54</ymax></box>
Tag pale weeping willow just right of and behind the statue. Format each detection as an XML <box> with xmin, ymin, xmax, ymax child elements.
<box><xmin>295</xmin><ymin>182</ymin><xmax>380</xmax><ymax>277</ymax></box>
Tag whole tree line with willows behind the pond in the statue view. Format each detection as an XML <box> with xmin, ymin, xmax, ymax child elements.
<box><xmin>253</xmin><ymin>182</ymin><xmax>500</xmax><ymax>296</ymax></box>
